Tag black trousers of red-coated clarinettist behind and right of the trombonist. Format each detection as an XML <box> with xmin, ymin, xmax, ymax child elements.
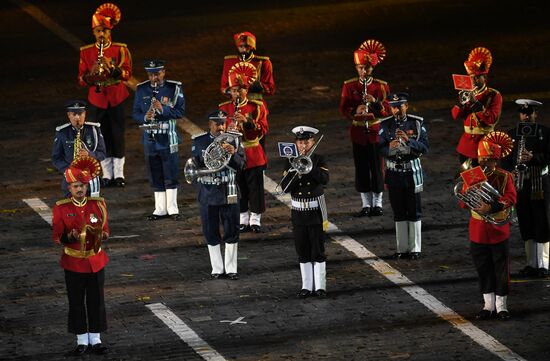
<box><xmin>352</xmin><ymin>143</ymin><xmax>384</xmax><ymax>193</ymax></box>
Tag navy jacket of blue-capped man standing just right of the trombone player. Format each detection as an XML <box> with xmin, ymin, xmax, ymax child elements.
<box><xmin>378</xmin><ymin>114</ymin><xmax>429</xmax><ymax>191</ymax></box>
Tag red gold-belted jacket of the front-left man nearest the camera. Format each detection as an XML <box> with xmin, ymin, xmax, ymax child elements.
<box><xmin>52</xmin><ymin>197</ymin><xmax>109</xmax><ymax>273</ymax></box>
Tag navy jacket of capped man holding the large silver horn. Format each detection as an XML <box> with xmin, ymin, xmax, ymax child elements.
<box><xmin>191</xmin><ymin>133</ymin><xmax>246</xmax><ymax>206</ymax></box>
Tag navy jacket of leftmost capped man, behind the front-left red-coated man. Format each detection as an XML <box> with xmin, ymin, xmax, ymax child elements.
<box><xmin>52</xmin><ymin>122</ymin><xmax>105</xmax><ymax>172</ymax></box>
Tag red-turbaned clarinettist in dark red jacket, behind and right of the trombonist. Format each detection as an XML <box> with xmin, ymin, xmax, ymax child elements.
<box><xmin>340</xmin><ymin>39</ymin><xmax>391</xmax><ymax>217</ymax></box>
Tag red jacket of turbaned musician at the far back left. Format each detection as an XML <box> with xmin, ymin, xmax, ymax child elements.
<box><xmin>78</xmin><ymin>43</ymin><xmax>132</xmax><ymax>109</ymax></box>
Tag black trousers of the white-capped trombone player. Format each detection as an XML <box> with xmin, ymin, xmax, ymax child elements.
<box><xmin>292</xmin><ymin>224</ymin><xmax>326</xmax><ymax>263</ymax></box>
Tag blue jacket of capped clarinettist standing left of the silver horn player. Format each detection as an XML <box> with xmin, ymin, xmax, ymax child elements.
<box><xmin>132</xmin><ymin>80</ymin><xmax>185</xmax><ymax>155</ymax></box>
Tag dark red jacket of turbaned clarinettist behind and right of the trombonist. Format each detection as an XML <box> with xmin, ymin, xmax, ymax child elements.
<box><xmin>340</xmin><ymin>78</ymin><xmax>391</xmax><ymax>145</ymax></box>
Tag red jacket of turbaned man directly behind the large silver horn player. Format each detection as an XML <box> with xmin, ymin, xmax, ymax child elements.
<box><xmin>219</xmin><ymin>100</ymin><xmax>268</xmax><ymax>169</ymax></box>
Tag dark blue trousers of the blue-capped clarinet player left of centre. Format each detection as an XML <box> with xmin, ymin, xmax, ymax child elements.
<box><xmin>145</xmin><ymin>151</ymin><xmax>179</xmax><ymax>192</ymax></box>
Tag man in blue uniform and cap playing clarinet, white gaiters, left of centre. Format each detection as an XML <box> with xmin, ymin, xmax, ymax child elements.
<box><xmin>133</xmin><ymin>60</ymin><xmax>185</xmax><ymax>221</ymax></box>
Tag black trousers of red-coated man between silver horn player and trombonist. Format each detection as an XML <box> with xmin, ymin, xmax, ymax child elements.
<box><xmin>237</xmin><ymin>166</ymin><xmax>265</xmax><ymax>213</ymax></box>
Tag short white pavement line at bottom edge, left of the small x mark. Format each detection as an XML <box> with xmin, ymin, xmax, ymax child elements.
<box><xmin>145</xmin><ymin>303</ymin><xmax>229</xmax><ymax>361</ymax></box>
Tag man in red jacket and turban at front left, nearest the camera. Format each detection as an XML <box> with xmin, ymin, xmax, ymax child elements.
<box><xmin>52</xmin><ymin>160</ymin><xmax>109</xmax><ymax>356</ymax></box>
